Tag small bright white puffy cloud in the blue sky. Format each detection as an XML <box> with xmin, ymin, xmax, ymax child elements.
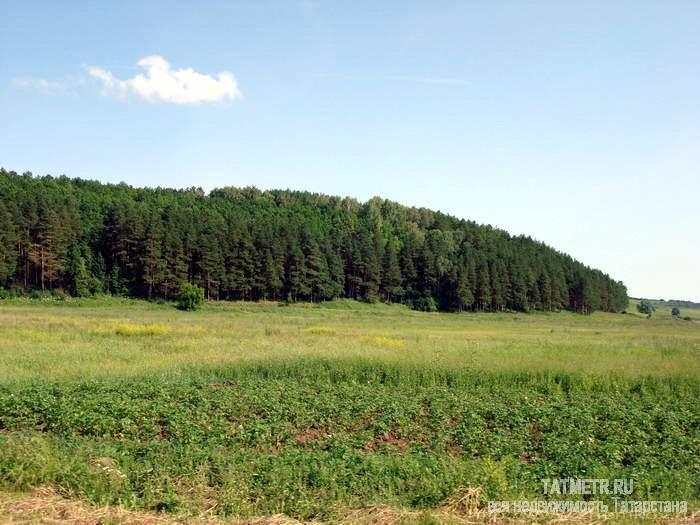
<box><xmin>88</xmin><ymin>55</ymin><xmax>241</xmax><ymax>104</ymax></box>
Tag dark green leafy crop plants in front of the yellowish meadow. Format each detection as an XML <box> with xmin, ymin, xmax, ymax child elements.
<box><xmin>0</xmin><ymin>361</ymin><xmax>700</xmax><ymax>520</ymax></box>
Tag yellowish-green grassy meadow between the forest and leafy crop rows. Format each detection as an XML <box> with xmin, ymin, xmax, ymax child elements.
<box><xmin>0</xmin><ymin>299</ymin><xmax>700</xmax><ymax>383</ymax></box>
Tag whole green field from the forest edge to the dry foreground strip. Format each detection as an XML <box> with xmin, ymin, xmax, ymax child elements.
<box><xmin>0</xmin><ymin>299</ymin><xmax>700</xmax><ymax>523</ymax></box>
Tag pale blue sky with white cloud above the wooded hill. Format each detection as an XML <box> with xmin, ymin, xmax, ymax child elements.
<box><xmin>0</xmin><ymin>0</ymin><xmax>700</xmax><ymax>300</ymax></box>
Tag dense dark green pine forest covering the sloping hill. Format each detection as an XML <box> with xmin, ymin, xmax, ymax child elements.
<box><xmin>0</xmin><ymin>169</ymin><xmax>627</xmax><ymax>313</ymax></box>
